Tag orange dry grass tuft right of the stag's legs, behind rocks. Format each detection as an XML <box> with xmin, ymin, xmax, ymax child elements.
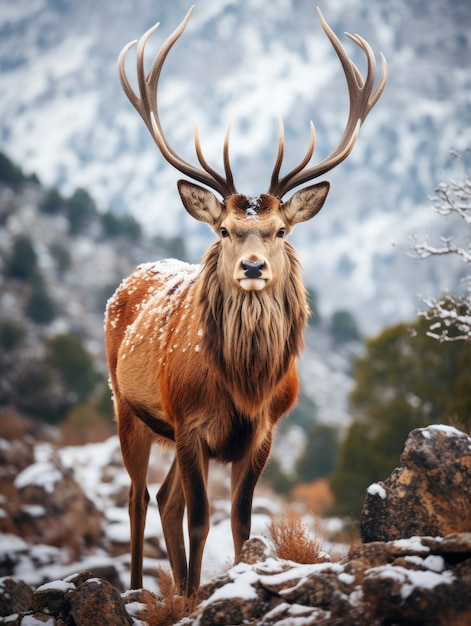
<box><xmin>268</xmin><ymin>510</ymin><xmax>325</xmax><ymax>563</ymax></box>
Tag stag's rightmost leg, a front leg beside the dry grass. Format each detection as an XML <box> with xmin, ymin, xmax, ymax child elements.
<box><xmin>231</xmin><ymin>437</ymin><xmax>271</xmax><ymax>561</ymax></box>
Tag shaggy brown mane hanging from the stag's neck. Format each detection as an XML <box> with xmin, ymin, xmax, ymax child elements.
<box><xmin>199</xmin><ymin>242</ymin><xmax>308</xmax><ymax>409</ymax></box>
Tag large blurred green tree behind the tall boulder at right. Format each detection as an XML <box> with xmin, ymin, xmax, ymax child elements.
<box><xmin>331</xmin><ymin>318</ymin><xmax>471</xmax><ymax>516</ymax></box>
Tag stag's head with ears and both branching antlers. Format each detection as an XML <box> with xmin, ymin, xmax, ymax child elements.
<box><xmin>118</xmin><ymin>7</ymin><xmax>387</xmax><ymax>291</ymax></box>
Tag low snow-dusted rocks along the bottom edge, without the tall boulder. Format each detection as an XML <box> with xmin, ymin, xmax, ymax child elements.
<box><xmin>0</xmin><ymin>533</ymin><xmax>471</xmax><ymax>626</ymax></box>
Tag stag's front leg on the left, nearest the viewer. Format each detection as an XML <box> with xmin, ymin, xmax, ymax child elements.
<box><xmin>176</xmin><ymin>432</ymin><xmax>209</xmax><ymax>596</ymax></box>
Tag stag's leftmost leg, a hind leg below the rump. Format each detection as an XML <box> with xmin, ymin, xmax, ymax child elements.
<box><xmin>117</xmin><ymin>403</ymin><xmax>152</xmax><ymax>589</ymax></box>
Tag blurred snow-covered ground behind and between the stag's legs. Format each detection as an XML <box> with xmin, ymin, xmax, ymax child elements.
<box><xmin>0</xmin><ymin>436</ymin><xmax>342</xmax><ymax>590</ymax></box>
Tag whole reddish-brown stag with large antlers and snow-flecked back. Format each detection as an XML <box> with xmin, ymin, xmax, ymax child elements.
<box><xmin>106</xmin><ymin>8</ymin><xmax>387</xmax><ymax>595</ymax></box>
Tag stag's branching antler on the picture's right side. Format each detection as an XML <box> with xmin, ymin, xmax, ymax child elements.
<box><xmin>268</xmin><ymin>9</ymin><xmax>388</xmax><ymax>198</ymax></box>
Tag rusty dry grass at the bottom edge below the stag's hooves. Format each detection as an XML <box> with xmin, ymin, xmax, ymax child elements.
<box><xmin>139</xmin><ymin>567</ymin><xmax>198</xmax><ymax>626</ymax></box>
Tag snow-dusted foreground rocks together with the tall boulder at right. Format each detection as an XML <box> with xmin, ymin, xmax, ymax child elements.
<box><xmin>0</xmin><ymin>426</ymin><xmax>471</xmax><ymax>626</ymax></box>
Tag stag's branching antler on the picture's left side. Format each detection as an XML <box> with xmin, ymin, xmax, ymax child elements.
<box><xmin>118</xmin><ymin>6</ymin><xmax>237</xmax><ymax>198</ymax></box>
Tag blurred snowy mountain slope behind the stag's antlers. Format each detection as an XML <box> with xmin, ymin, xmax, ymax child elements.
<box><xmin>0</xmin><ymin>0</ymin><xmax>471</xmax><ymax>333</ymax></box>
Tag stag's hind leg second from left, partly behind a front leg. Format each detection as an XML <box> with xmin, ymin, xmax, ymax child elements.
<box><xmin>157</xmin><ymin>457</ymin><xmax>187</xmax><ymax>594</ymax></box>
